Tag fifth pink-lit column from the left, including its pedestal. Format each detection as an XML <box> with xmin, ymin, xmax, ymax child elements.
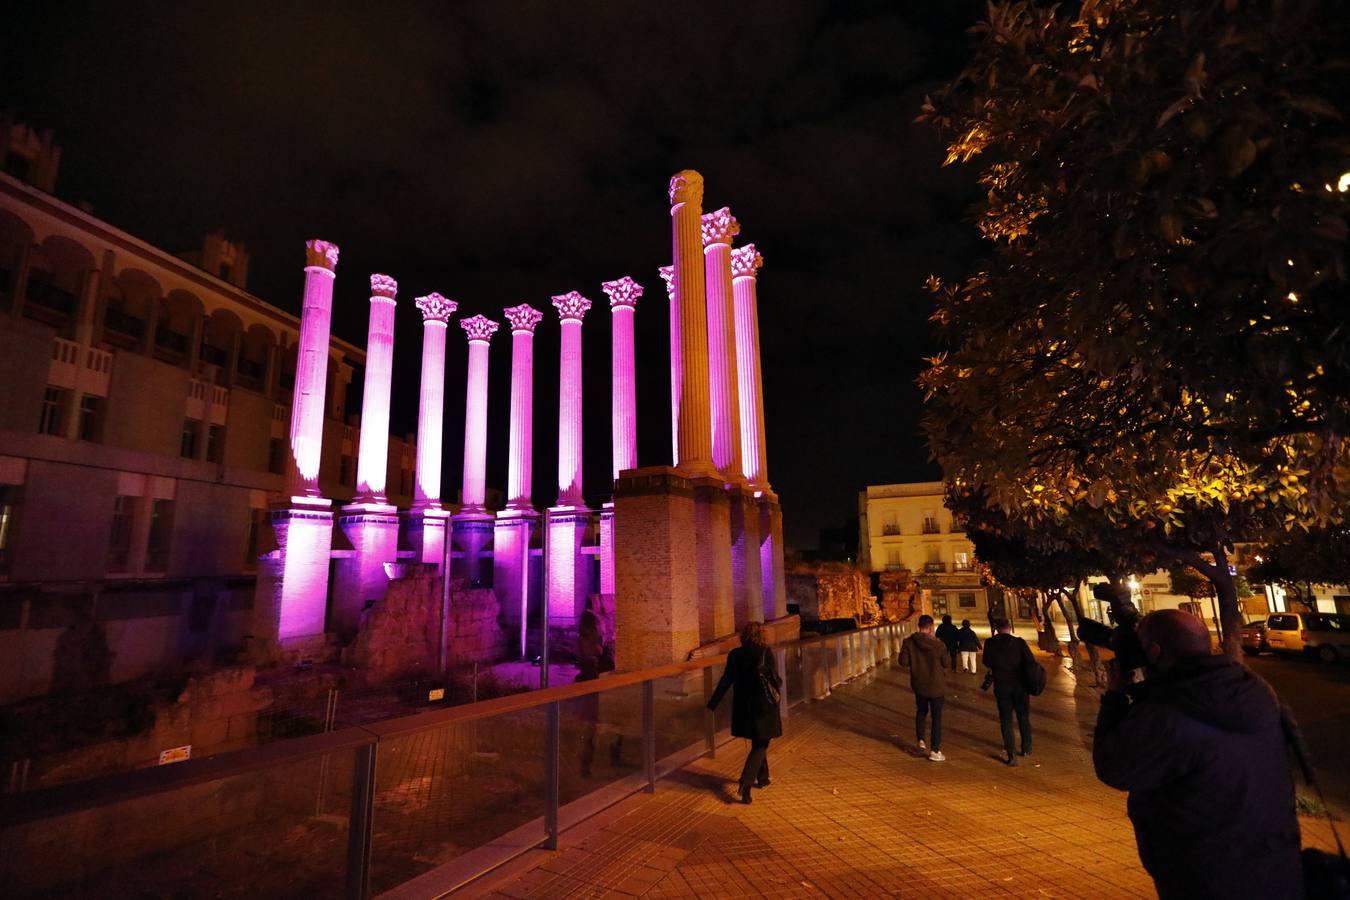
<box><xmin>493</xmin><ymin>304</ymin><xmax>544</xmax><ymax>657</ymax></box>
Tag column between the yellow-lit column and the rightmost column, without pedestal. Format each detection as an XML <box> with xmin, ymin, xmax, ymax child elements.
<box><xmin>702</xmin><ymin>206</ymin><xmax>744</xmax><ymax>482</ymax></box>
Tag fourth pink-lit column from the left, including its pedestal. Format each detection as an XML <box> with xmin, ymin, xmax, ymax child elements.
<box><xmin>454</xmin><ymin>316</ymin><xmax>497</xmax><ymax>584</ymax></box>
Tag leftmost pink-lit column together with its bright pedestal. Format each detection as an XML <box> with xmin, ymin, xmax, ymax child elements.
<box><xmin>254</xmin><ymin>240</ymin><xmax>338</xmax><ymax>658</ymax></box>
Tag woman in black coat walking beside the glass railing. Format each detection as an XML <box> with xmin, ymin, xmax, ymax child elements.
<box><xmin>707</xmin><ymin>622</ymin><xmax>783</xmax><ymax>803</ymax></box>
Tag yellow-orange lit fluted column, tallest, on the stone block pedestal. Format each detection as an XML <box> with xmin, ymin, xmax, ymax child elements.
<box><xmin>668</xmin><ymin>169</ymin><xmax>716</xmax><ymax>475</ymax></box>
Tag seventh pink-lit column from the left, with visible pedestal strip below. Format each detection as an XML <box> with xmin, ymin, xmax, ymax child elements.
<box><xmin>599</xmin><ymin>275</ymin><xmax>643</xmax><ymax>596</ymax></box>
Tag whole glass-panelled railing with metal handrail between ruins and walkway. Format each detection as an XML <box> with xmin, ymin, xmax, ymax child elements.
<box><xmin>0</xmin><ymin>622</ymin><xmax>911</xmax><ymax>899</ymax></box>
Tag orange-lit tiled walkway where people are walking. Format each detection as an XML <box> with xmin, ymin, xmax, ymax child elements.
<box><xmin>460</xmin><ymin>657</ymin><xmax>1330</xmax><ymax>900</ymax></box>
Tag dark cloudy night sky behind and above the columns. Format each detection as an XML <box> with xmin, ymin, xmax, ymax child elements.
<box><xmin>0</xmin><ymin>0</ymin><xmax>980</xmax><ymax>549</ymax></box>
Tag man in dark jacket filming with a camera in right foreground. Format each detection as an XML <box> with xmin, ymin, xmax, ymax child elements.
<box><xmin>1092</xmin><ymin>610</ymin><xmax>1303</xmax><ymax>900</ymax></box>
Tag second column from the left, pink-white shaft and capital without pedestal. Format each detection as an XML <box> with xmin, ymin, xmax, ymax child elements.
<box><xmin>356</xmin><ymin>275</ymin><xmax>398</xmax><ymax>505</ymax></box>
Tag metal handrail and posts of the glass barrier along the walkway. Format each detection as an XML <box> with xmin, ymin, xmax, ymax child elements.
<box><xmin>0</xmin><ymin>621</ymin><xmax>909</xmax><ymax>900</ymax></box>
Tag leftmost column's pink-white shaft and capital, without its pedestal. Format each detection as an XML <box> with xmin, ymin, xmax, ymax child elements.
<box><xmin>286</xmin><ymin>240</ymin><xmax>338</xmax><ymax>501</ymax></box>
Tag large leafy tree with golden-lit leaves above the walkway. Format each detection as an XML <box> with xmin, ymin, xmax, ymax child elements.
<box><xmin>921</xmin><ymin>0</ymin><xmax>1350</xmax><ymax>654</ymax></box>
